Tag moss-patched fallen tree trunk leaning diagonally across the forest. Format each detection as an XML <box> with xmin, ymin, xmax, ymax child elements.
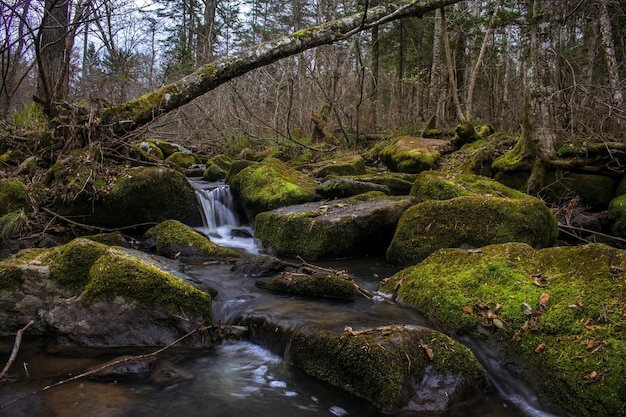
<box><xmin>99</xmin><ymin>0</ymin><xmax>460</xmax><ymax>135</ymax></box>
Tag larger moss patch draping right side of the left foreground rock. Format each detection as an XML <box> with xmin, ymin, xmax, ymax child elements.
<box><xmin>81</xmin><ymin>251</ymin><xmax>212</xmax><ymax>324</ymax></box>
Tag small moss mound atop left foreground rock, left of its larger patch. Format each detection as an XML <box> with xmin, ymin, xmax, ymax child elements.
<box><xmin>50</xmin><ymin>238</ymin><xmax>109</xmax><ymax>291</ymax></box>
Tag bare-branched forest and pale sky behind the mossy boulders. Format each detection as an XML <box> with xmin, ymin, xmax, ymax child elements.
<box><xmin>0</xmin><ymin>0</ymin><xmax>626</xmax><ymax>170</ymax></box>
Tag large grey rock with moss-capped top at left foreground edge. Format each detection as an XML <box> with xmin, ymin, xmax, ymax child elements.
<box><xmin>0</xmin><ymin>238</ymin><xmax>212</xmax><ymax>347</ymax></box>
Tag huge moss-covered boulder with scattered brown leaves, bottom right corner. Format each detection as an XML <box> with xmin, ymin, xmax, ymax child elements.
<box><xmin>381</xmin><ymin>243</ymin><xmax>626</xmax><ymax>417</ymax></box>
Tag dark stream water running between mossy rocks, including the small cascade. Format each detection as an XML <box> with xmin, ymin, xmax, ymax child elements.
<box><xmin>0</xmin><ymin>182</ymin><xmax>548</xmax><ymax>417</ymax></box>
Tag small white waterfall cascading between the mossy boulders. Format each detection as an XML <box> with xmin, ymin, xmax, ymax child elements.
<box><xmin>191</xmin><ymin>181</ymin><xmax>261</xmax><ymax>254</ymax></box>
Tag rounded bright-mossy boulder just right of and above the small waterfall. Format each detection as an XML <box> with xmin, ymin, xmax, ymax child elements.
<box><xmin>228</xmin><ymin>158</ymin><xmax>317</xmax><ymax>214</ymax></box>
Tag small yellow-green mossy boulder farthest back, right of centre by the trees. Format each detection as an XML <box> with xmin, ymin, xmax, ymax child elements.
<box><xmin>377</xmin><ymin>136</ymin><xmax>452</xmax><ymax>174</ymax></box>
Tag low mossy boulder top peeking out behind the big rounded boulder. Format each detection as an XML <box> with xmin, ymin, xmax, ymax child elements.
<box><xmin>410</xmin><ymin>171</ymin><xmax>529</xmax><ymax>200</ymax></box>
